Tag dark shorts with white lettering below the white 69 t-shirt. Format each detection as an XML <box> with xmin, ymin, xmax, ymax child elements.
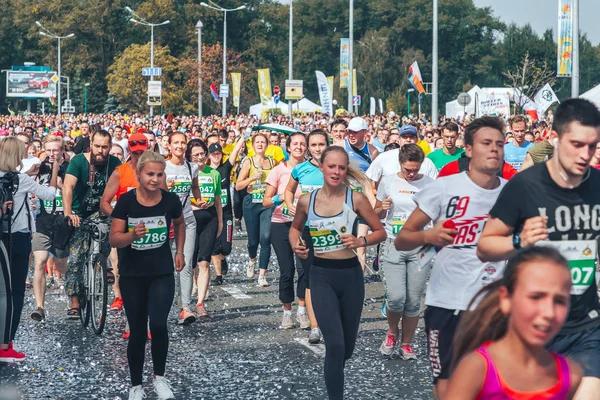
<box><xmin>424</xmin><ymin>306</ymin><xmax>463</xmax><ymax>385</ymax></box>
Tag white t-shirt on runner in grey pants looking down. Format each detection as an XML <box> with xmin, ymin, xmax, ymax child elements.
<box><xmin>377</xmin><ymin>174</ymin><xmax>434</xmax><ymax>239</ymax></box>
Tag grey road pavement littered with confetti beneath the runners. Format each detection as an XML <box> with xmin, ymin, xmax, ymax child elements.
<box><xmin>0</xmin><ymin>236</ymin><xmax>432</xmax><ymax>400</ymax></box>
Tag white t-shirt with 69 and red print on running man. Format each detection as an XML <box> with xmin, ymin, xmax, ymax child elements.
<box><xmin>415</xmin><ymin>172</ymin><xmax>507</xmax><ymax>310</ymax></box>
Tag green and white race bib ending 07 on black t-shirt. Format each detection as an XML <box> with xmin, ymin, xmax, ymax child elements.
<box><xmin>538</xmin><ymin>240</ymin><xmax>598</xmax><ymax>295</ymax></box>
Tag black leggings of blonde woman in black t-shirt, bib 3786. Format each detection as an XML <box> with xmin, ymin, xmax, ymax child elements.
<box><xmin>119</xmin><ymin>274</ymin><xmax>175</xmax><ymax>386</ymax></box>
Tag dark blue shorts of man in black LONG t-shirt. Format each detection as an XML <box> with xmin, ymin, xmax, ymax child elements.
<box><xmin>547</xmin><ymin>326</ymin><xmax>600</xmax><ymax>378</ymax></box>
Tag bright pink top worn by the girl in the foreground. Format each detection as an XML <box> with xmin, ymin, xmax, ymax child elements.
<box><xmin>477</xmin><ymin>342</ymin><xmax>571</xmax><ymax>400</ymax></box>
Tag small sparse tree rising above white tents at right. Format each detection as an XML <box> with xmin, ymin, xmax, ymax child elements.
<box><xmin>504</xmin><ymin>52</ymin><xmax>556</xmax><ymax>112</ymax></box>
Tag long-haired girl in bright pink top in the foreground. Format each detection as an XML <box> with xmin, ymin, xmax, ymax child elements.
<box><xmin>443</xmin><ymin>247</ymin><xmax>583</xmax><ymax>400</ymax></box>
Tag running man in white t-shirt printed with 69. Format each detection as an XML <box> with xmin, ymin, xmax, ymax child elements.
<box><xmin>394</xmin><ymin>117</ymin><xmax>506</xmax><ymax>400</ymax></box>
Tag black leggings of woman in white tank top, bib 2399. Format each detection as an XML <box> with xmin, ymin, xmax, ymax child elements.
<box><xmin>310</xmin><ymin>257</ymin><xmax>365</xmax><ymax>400</ymax></box>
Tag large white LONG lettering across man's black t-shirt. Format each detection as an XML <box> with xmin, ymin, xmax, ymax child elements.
<box><xmin>538</xmin><ymin>204</ymin><xmax>600</xmax><ymax>240</ymax></box>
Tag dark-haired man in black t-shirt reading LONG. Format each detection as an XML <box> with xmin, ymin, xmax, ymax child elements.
<box><xmin>477</xmin><ymin>99</ymin><xmax>600</xmax><ymax>400</ymax></box>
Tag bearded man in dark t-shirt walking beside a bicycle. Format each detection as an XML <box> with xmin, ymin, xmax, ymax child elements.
<box><xmin>63</xmin><ymin>130</ymin><xmax>121</xmax><ymax>319</ymax></box>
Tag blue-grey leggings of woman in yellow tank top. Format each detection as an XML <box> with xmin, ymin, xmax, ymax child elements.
<box><xmin>243</xmin><ymin>196</ymin><xmax>273</xmax><ymax>269</ymax></box>
